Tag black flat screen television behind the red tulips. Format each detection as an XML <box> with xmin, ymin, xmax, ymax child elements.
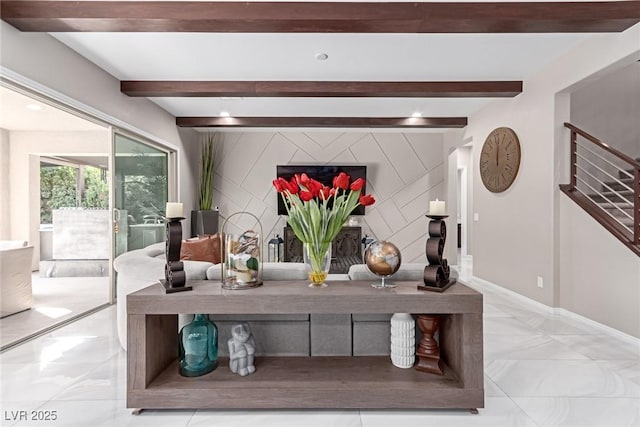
<box><xmin>276</xmin><ymin>165</ymin><xmax>367</xmax><ymax>215</ymax></box>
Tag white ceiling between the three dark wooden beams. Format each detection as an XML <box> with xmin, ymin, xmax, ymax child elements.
<box><xmin>53</xmin><ymin>33</ymin><xmax>591</xmax><ymax>117</ymax></box>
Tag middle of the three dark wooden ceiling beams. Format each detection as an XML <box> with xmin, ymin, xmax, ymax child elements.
<box><xmin>120</xmin><ymin>80</ymin><xmax>522</xmax><ymax>98</ymax></box>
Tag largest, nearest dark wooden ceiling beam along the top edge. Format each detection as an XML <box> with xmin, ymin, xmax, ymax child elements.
<box><xmin>0</xmin><ymin>0</ymin><xmax>640</xmax><ymax>33</ymax></box>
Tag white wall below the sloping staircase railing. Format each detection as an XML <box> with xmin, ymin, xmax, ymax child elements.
<box><xmin>559</xmin><ymin>194</ymin><xmax>640</xmax><ymax>337</ymax></box>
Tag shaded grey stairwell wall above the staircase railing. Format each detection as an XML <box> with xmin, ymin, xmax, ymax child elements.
<box><xmin>571</xmin><ymin>61</ymin><xmax>640</xmax><ymax>158</ymax></box>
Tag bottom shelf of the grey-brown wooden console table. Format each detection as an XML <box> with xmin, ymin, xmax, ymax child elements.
<box><xmin>131</xmin><ymin>356</ymin><xmax>483</xmax><ymax>409</ymax></box>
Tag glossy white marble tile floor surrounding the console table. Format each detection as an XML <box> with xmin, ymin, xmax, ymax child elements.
<box><xmin>0</xmin><ymin>262</ymin><xmax>640</xmax><ymax>427</ymax></box>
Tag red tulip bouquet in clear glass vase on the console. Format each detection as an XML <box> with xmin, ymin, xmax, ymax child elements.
<box><xmin>273</xmin><ymin>172</ymin><xmax>375</xmax><ymax>285</ymax></box>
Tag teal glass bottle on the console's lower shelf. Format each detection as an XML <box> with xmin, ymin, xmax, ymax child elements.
<box><xmin>178</xmin><ymin>314</ymin><xmax>218</xmax><ymax>377</ymax></box>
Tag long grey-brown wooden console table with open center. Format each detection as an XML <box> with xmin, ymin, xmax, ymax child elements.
<box><xmin>127</xmin><ymin>281</ymin><xmax>484</xmax><ymax>409</ymax></box>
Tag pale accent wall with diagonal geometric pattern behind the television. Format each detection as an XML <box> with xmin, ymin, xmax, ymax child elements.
<box><xmin>214</xmin><ymin>131</ymin><xmax>445</xmax><ymax>263</ymax></box>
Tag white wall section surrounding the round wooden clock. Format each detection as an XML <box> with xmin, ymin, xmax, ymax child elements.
<box><xmin>467</xmin><ymin>88</ymin><xmax>553</xmax><ymax>305</ymax></box>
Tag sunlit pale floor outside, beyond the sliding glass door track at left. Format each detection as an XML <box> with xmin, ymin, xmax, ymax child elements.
<box><xmin>0</xmin><ymin>272</ymin><xmax>109</xmax><ymax>347</ymax></box>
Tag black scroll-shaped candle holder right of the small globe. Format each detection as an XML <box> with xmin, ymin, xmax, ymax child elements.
<box><xmin>418</xmin><ymin>215</ymin><xmax>456</xmax><ymax>292</ymax></box>
